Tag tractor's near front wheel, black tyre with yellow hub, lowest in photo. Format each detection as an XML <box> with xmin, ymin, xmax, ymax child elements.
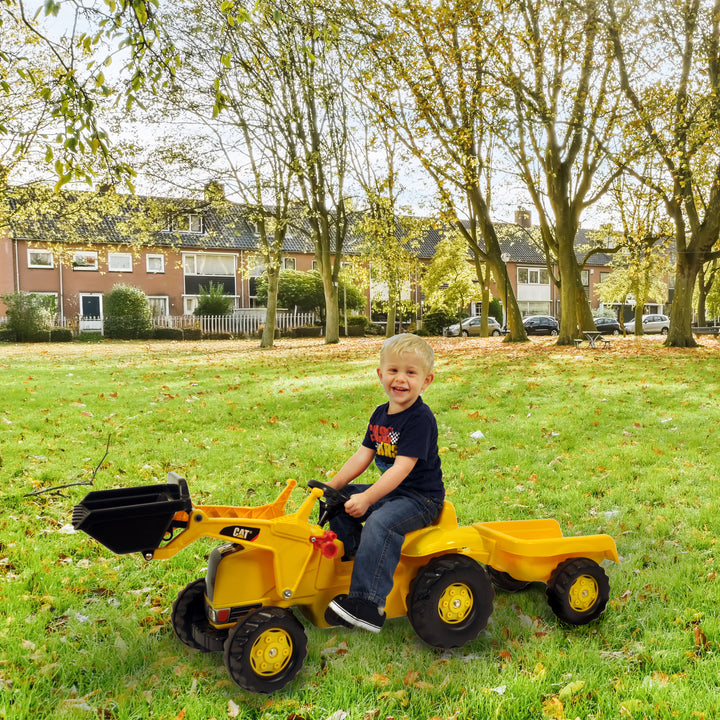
<box><xmin>224</xmin><ymin>607</ymin><xmax>307</xmax><ymax>693</ymax></box>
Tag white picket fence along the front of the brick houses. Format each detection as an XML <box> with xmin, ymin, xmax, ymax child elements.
<box><xmin>0</xmin><ymin>311</ymin><xmax>315</xmax><ymax>335</ymax></box>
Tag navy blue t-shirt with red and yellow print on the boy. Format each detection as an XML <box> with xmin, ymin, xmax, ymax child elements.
<box><xmin>362</xmin><ymin>397</ymin><xmax>445</xmax><ymax>500</ymax></box>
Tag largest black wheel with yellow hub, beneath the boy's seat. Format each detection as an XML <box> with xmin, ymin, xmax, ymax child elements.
<box><xmin>408</xmin><ymin>554</ymin><xmax>495</xmax><ymax>648</ymax></box>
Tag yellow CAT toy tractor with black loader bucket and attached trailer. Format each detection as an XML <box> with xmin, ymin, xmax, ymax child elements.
<box><xmin>72</xmin><ymin>473</ymin><xmax>618</xmax><ymax>693</ymax></box>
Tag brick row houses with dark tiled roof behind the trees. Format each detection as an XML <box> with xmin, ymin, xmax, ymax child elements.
<box><xmin>0</xmin><ymin>191</ymin><xmax>610</xmax><ymax>329</ymax></box>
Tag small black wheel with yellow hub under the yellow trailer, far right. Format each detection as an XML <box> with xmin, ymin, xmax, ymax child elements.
<box><xmin>545</xmin><ymin>558</ymin><xmax>610</xmax><ymax>625</ymax></box>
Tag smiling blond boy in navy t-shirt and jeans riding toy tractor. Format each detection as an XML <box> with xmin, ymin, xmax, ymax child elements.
<box><xmin>326</xmin><ymin>334</ymin><xmax>445</xmax><ymax>632</ymax></box>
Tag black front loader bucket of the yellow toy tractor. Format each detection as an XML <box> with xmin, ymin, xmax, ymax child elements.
<box><xmin>72</xmin><ymin>473</ymin><xmax>192</xmax><ymax>555</ymax></box>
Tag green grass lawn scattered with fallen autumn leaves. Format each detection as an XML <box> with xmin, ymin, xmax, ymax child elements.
<box><xmin>0</xmin><ymin>338</ymin><xmax>720</xmax><ymax>720</ymax></box>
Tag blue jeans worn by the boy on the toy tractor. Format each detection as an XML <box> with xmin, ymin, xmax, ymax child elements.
<box><xmin>330</xmin><ymin>484</ymin><xmax>443</xmax><ymax>607</ymax></box>
